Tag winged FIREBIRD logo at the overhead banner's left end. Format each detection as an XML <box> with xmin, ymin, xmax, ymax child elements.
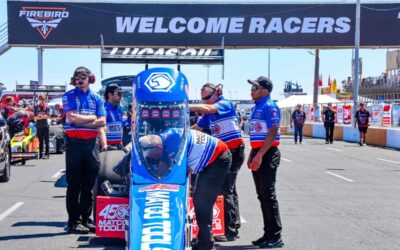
<box><xmin>19</xmin><ymin>7</ymin><xmax>69</xmax><ymax>40</ymax></box>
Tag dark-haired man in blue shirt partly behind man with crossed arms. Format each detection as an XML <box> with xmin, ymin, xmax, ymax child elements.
<box><xmin>100</xmin><ymin>83</ymin><xmax>123</xmax><ymax>151</ymax></box>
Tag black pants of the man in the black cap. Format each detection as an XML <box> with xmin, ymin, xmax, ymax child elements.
<box><xmin>251</xmin><ymin>147</ymin><xmax>282</xmax><ymax>238</ymax></box>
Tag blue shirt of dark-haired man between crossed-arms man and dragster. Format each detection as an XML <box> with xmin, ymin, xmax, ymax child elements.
<box><xmin>104</xmin><ymin>102</ymin><xmax>123</xmax><ymax>145</ymax></box>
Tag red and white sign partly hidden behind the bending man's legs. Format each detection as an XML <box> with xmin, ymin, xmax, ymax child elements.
<box><xmin>189</xmin><ymin>195</ymin><xmax>225</xmax><ymax>238</ymax></box>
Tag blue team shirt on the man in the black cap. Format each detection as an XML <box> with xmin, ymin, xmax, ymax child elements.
<box><xmin>250</xmin><ymin>96</ymin><xmax>281</xmax><ymax>148</ymax></box>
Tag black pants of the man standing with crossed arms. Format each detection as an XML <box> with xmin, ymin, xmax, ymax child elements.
<box><xmin>65</xmin><ymin>138</ymin><xmax>100</xmax><ymax>226</ymax></box>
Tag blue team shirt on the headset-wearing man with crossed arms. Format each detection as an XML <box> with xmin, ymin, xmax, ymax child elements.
<box><xmin>63</xmin><ymin>87</ymin><xmax>106</xmax><ymax>139</ymax></box>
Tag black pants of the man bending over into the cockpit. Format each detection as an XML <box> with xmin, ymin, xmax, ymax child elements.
<box><xmin>193</xmin><ymin>151</ymin><xmax>232</xmax><ymax>249</ymax></box>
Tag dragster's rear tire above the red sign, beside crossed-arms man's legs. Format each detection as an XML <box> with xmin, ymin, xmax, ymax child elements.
<box><xmin>93</xmin><ymin>150</ymin><xmax>125</xmax><ymax>221</ymax></box>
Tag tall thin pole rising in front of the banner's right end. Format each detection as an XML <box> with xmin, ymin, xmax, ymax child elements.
<box><xmin>351</xmin><ymin>0</ymin><xmax>361</xmax><ymax>126</ymax></box>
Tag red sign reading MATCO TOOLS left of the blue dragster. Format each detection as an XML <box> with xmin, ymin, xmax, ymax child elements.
<box><xmin>96</xmin><ymin>196</ymin><xmax>129</xmax><ymax>239</ymax></box>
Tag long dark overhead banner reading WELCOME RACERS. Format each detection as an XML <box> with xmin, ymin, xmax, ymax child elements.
<box><xmin>7</xmin><ymin>0</ymin><xmax>400</xmax><ymax>48</ymax></box>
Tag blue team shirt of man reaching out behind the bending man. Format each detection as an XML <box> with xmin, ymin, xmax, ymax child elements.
<box><xmin>197</xmin><ymin>96</ymin><xmax>244</xmax><ymax>149</ymax></box>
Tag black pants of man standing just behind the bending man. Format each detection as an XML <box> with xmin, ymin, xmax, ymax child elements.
<box><xmin>221</xmin><ymin>148</ymin><xmax>244</xmax><ymax>236</ymax></box>
